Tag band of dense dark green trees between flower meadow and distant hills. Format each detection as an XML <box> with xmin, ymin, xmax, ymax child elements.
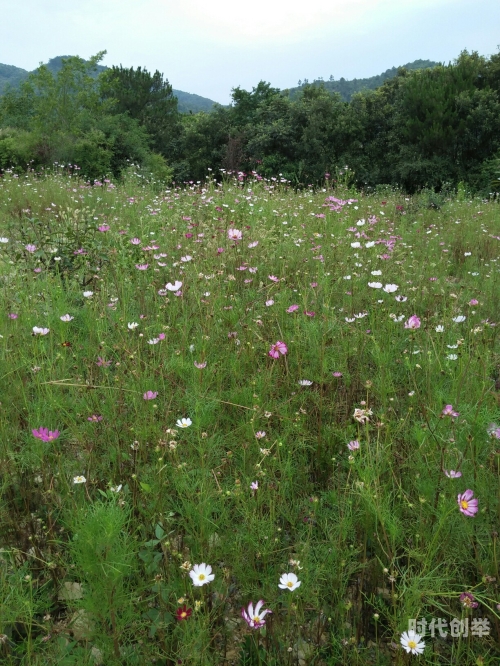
<box><xmin>0</xmin><ymin>51</ymin><xmax>500</xmax><ymax>192</ymax></box>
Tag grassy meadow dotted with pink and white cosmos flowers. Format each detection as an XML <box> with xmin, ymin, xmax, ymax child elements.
<box><xmin>0</xmin><ymin>169</ymin><xmax>500</xmax><ymax>666</ymax></box>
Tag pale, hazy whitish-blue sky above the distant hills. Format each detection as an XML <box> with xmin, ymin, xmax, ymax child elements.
<box><xmin>0</xmin><ymin>0</ymin><xmax>500</xmax><ymax>104</ymax></box>
